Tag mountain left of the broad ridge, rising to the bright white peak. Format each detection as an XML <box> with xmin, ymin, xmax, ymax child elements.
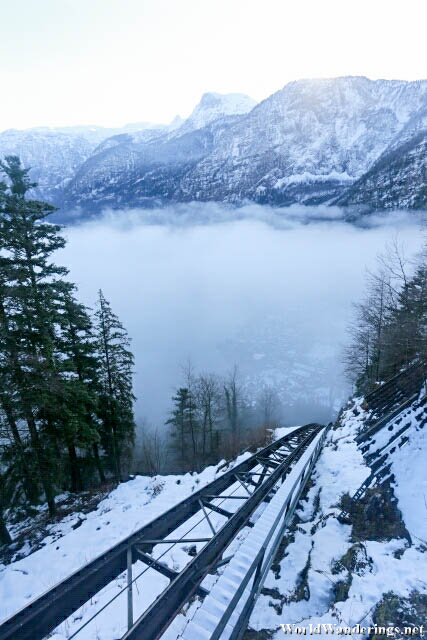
<box><xmin>58</xmin><ymin>93</ymin><xmax>256</xmax><ymax>211</ymax></box>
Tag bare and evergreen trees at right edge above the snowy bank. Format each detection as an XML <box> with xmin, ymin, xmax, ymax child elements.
<box><xmin>344</xmin><ymin>241</ymin><xmax>427</xmax><ymax>394</ymax></box>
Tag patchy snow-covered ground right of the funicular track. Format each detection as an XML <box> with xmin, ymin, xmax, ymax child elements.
<box><xmin>250</xmin><ymin>392</ymin><xmax>427</xmax><ymax>640</ymax></box>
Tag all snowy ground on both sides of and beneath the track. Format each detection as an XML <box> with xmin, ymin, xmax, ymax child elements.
<box><xmin>0</xmin><ymin>399</ymin><xmax>427</xmax><ymax>640</ymax></box>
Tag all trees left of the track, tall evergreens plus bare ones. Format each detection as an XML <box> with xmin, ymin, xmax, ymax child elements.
<box><xmin>0</xmin><ymin>156</ymin><xmax>277</xmax><ymax>543</ymax></box>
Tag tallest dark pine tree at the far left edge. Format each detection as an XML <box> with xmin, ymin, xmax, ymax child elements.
<box><xmin>0</xmin><ymin>156</ymin><xmax>71</xmax><ymax>514</ymax></box>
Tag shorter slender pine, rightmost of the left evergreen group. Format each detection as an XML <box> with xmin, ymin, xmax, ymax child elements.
<box><xmin>95</xmin><ymin>291</ymin><xmax>135</xmax><ymax>482</ymax></box>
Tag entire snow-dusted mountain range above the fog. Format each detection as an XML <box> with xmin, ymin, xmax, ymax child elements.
<box><xmin>0</xmin><ymin>77</ymin><xmax>427</xmax><ymax>214</ymax></box>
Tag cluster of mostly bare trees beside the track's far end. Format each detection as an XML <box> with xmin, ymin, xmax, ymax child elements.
<box><xmin>136</xmin><ymin>364</ymin><xmax>281</xmax><ymax>474</ymax></box>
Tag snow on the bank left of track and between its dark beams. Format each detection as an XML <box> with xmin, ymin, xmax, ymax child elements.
<box><xmin>0</xmin><ymin>452</ymin><xmax>258</xmax><ymax>640</ymax></box>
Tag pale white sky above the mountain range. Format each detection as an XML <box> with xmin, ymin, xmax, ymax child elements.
<box><xmin>0</xmin><ymin>0</ymin><xmax>427</xmax><ymax>131</ymax></box>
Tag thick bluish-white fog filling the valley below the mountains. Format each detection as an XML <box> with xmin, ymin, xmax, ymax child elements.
<box><xmin>55</xmin><ymin>203</ymin><xmax>423</xmax><ymax>426</ymax></box>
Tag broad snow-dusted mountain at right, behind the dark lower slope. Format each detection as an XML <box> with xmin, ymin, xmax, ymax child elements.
<box><xmin>181</xmin><ymin>77</ymin><xmax>427</xmax><ymax>205</ymax></box>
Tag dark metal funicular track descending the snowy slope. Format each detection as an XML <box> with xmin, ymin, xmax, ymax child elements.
<box><xmin>0</xmin><ymin>424</ymin><xmax>327</xmax><ymax>640</ymax></box>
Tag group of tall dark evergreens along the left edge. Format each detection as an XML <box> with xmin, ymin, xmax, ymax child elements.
<box><xmin>0</xmin><ymin>156</ymin><xmax>135</xmax><ymax>542</ymax></box>
